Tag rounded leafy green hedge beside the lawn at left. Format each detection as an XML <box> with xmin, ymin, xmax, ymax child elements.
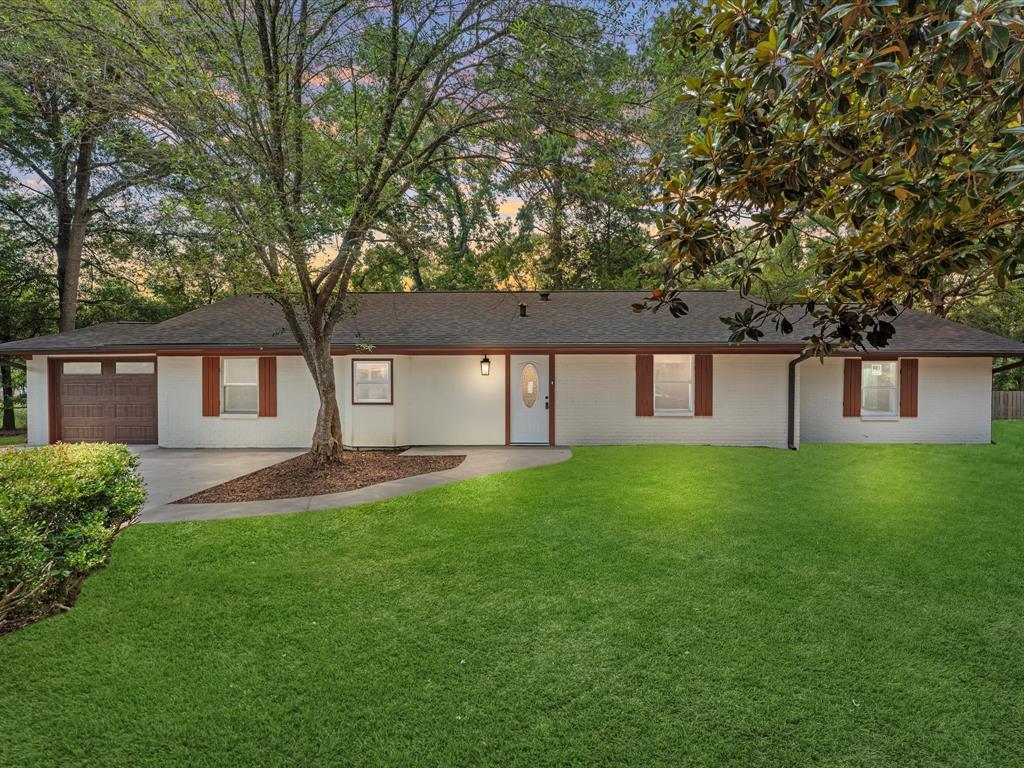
<box><xmin>0</xmin><ymin>443</ymin><xmax>145</xmax><ymax>634</ymax></box>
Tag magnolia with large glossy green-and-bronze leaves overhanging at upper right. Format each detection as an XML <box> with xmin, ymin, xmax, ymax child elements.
<box><xmin>637</xmin><ymin>0</ymin><xmax>1024</xmax><ymax>354</ymax></box>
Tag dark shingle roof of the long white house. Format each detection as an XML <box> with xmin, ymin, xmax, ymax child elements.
<box><xmin>0</xmin><ymin>291</ymin><xmax>1024</xmax><ymax>356</ymax></box>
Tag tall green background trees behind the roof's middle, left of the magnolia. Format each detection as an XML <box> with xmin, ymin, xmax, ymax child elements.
<box><xmin>357</xmin><ymin>3</ymin><xmax>678</xmax><ymax>290</ymax></box>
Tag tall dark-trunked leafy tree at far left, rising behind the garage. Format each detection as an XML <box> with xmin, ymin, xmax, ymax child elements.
<box><xmin>0</xmin><ymin>0</ymin><xmax>167</xmax><ymax>331</ymax></box>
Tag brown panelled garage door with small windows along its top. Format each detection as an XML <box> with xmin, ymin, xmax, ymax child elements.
<box><xmin>50</xmin><ymin>357</ymin><xmax>157</xmax><ymax>443</ymax></box>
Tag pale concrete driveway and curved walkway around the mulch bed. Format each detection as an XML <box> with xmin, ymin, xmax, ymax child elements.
<box><xmin>139</xmin><ymin>445</ymin><xmax>572</xmax><ymax>522</ymax></box>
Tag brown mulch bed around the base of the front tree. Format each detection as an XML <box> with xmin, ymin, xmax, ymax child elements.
<box><xmin>174</xmin><ymin>451</ymin><xmax>466</xmax><ymax>504</ymax></box>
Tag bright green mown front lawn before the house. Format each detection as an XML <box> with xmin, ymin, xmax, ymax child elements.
<box><xmin>0</xmin><ymin>423</ymin><xmax>1024</xmax><ymax>768</ymax></box>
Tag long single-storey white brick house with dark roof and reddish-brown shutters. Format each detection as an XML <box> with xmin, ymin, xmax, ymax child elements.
<box><xmin>0</xmin><ymin>292</ymin><xmax>1024</xmax><ymax>447</ymax></box>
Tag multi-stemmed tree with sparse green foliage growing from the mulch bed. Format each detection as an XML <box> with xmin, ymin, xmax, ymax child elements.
<box><xmin>102</xmin><ymin>0</ymin><xmax>593</xmax><ymax>462</ymax></box>
